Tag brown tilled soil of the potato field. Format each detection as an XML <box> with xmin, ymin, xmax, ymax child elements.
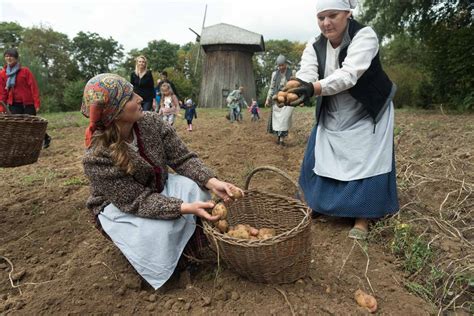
<box><xmin>0</xmin><ymin>109</ymin><xmax>474</xmax><ymax>315</ymax></box>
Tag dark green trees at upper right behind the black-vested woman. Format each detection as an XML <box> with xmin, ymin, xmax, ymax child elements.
<box><xmin>361</xmin><ymin>0</ymin><xmax>474</xmax><ymax>110</ymax></box>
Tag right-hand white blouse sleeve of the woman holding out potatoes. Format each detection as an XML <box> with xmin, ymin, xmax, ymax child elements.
<box><xmin>319</xmin><ymin>27</ymin><xmax>379</xmax><ymax>95</ymax></box>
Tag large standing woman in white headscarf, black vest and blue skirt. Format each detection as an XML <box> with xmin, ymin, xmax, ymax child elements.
<box><xmin>289</xmin><ymin>0</ymin><xmax>399</xmax><ymax>239</ymax></box>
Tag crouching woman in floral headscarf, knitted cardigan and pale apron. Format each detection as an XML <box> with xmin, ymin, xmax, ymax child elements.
<box><xmin>82</xmin><ymin>74</ymin><xmax>243</xmax><ymax>289</ymax></box>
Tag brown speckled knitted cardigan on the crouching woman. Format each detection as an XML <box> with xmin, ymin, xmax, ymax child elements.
<box><xmin>83</xmin><ymin>112</ymin><xmax>214</xmax><ymax>219</ymax></box>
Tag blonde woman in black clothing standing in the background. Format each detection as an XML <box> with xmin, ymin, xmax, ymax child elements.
<box><xmin>130</xmin><ymin>55</ymin><xmax>156</xmax><ymax>111</ymax></box>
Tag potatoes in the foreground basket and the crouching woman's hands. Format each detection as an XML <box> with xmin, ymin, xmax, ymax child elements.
<box><xmin>208</xmin><ymin>190</ymin><xmax>276</xmax><ymax>240</ymax></box>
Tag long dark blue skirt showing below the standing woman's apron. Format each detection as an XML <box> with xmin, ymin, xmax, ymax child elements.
<box><xmin>299</xmin><ymin>126</ymin><xmax>399</xmax><ymax>218</ymax></box>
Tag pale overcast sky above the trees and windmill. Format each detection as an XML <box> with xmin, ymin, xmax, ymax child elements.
<box><xmin>0</xmin><ymin>0</ymin><xmax>326</xmax><ymax>52</ymax></box>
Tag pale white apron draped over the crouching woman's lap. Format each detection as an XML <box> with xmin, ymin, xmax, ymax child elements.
<box><xmin>99</xmin><ymin>174</ymin><xmax>210</xmax><ymax>290</ymax></box>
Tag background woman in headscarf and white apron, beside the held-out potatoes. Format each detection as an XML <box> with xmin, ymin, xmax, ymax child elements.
<box><xmin>265</xmin><ymin>55</ymin><xmax>294</xmax><ymax>145</ymax></box>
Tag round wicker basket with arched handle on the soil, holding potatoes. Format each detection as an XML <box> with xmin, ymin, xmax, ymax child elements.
<box><xmin>203</xmin><ymin>166</ymin><xmax>311</xmax><ymax>283</ymax></box>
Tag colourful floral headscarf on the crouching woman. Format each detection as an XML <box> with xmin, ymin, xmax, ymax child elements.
<box><xmin>81</xmin><ymin>73</ymin><xmax>133</xmax><ymax>147</ymax></box>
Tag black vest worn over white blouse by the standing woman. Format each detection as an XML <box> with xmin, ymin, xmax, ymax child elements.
<box><xmin>313</xmin><ymin>19</ymin><xmax>396</xmax><ymax>124</ymax></box>
